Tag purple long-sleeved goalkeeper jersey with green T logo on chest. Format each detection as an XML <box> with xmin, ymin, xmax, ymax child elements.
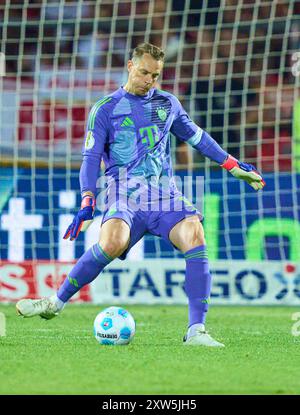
<box><xmin>80</xmin><ymin>87</ymin><xmax>227</xmax><ymax>205</ymax></box>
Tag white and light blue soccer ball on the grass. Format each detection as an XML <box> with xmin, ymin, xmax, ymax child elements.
<box><xmin>94</xmin><ymin>306</ymin><xmax>135</xmax><ymax>345</ymax></box>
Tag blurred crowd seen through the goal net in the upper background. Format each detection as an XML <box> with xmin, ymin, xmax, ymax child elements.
<box><xmin>0</xmin><ymin>0</ymin><xmax>300</xmax><ymax>171</ymax></box>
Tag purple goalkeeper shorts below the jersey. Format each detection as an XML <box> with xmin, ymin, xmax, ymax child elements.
<box><xmin>102</xmin><ymin>194</ymin><xmax>203</xmax><ymax>259</ymax></box>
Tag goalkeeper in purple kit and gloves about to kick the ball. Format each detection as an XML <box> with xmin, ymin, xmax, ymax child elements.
<box><xmin>16</xmin><ymin>43</ymin><xmax>264</xmax><ymax>347</ymax></box>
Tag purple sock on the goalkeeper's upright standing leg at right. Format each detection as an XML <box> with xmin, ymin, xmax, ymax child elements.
<box><xmin>184</xmin><ymin>245</ymin><xmax>211</xmax><ymax>327</ymax></box>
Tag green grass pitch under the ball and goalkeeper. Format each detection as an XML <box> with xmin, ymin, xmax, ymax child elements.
<box><xmin>0</xmin><ymin>304</ymin><xmax>300</xmax><ymax>395</ymax></box>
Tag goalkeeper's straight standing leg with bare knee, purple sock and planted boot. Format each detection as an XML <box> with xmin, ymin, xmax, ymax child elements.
<box><xmin>169</xmin><ymin>215</ymin><xmax>222</xmax><ymax>346</ymax></box>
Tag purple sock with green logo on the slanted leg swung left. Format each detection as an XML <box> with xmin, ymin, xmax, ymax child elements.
<box><xmin>57</xmin><ymin>243</ymin><xmax>113</xmax><ymax>303</ymax></box>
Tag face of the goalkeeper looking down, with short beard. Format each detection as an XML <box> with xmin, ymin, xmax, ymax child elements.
<box><xmin>127</xmin><ymin>53</ymin><xmax>163</xmax><ymax>95</ymax></box>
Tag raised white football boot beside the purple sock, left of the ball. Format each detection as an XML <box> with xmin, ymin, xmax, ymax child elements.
<box><xmin>16</xmin><ymin>295</ymin><xmax>62</xmax><ymax>320</ymax></box>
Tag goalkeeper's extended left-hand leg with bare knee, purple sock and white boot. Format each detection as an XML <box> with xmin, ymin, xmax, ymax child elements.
<box><xmin>16</xmin><ymin>219</ymin><xmax>130</xmax><ymax>318</ymax></box>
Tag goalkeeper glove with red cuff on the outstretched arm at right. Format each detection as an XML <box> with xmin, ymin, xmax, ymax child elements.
<box><xmin>221</xmin><ymin>155</ymin><xmax>266</xmax><ymax>190</ymax></box>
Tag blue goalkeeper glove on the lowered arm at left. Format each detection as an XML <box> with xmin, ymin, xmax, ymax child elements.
<box><xmin>63</xmin><ymin>196</ymin><xmax>96</xmax><ymax>241</ymax></box>
